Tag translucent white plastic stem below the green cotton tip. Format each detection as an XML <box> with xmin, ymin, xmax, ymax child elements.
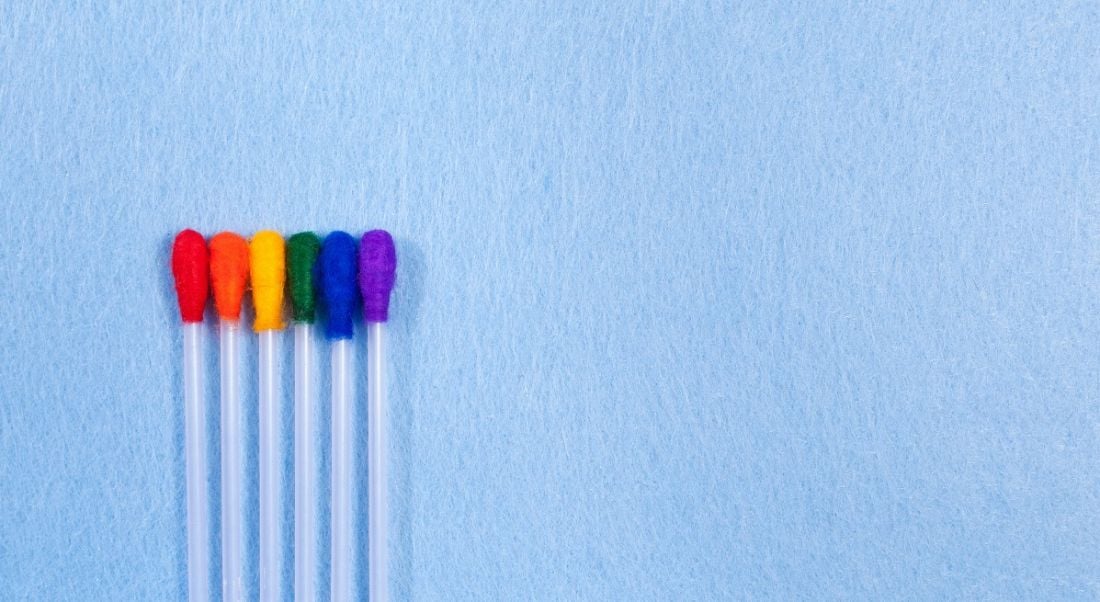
<box><xmin>294</xmin><ymin>324</ymin><xmax>317</xmax><ymax>602</ymax></box>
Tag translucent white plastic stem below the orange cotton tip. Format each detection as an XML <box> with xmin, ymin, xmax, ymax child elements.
<box><xmin>220</xmin><ymin>319</ymin><xmax>244</xmax><ymax>602</ymax></box>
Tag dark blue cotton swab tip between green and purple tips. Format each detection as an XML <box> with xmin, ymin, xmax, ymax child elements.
<box><xmin>317</xmin><ymin>232</ymin><xmax>359</xmax><ymax>339</ymax></box>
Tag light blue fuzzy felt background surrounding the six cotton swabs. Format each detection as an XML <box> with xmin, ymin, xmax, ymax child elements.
<box><xmin>0</xmin><ymin>1</ymin><xmax>1100</xmax><ymax>600</ymax></box>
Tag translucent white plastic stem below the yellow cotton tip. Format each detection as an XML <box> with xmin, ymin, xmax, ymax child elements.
<box><xmin>259</xmin><ymin>330</ymin><xmax>283</xmax><ymax>602</ymax></box>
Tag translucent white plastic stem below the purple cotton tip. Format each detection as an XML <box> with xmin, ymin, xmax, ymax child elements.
<box><xmin>366</xmin><ymin>322</ymin><xmax>389</xmax><ymax>602</ymax></box>
